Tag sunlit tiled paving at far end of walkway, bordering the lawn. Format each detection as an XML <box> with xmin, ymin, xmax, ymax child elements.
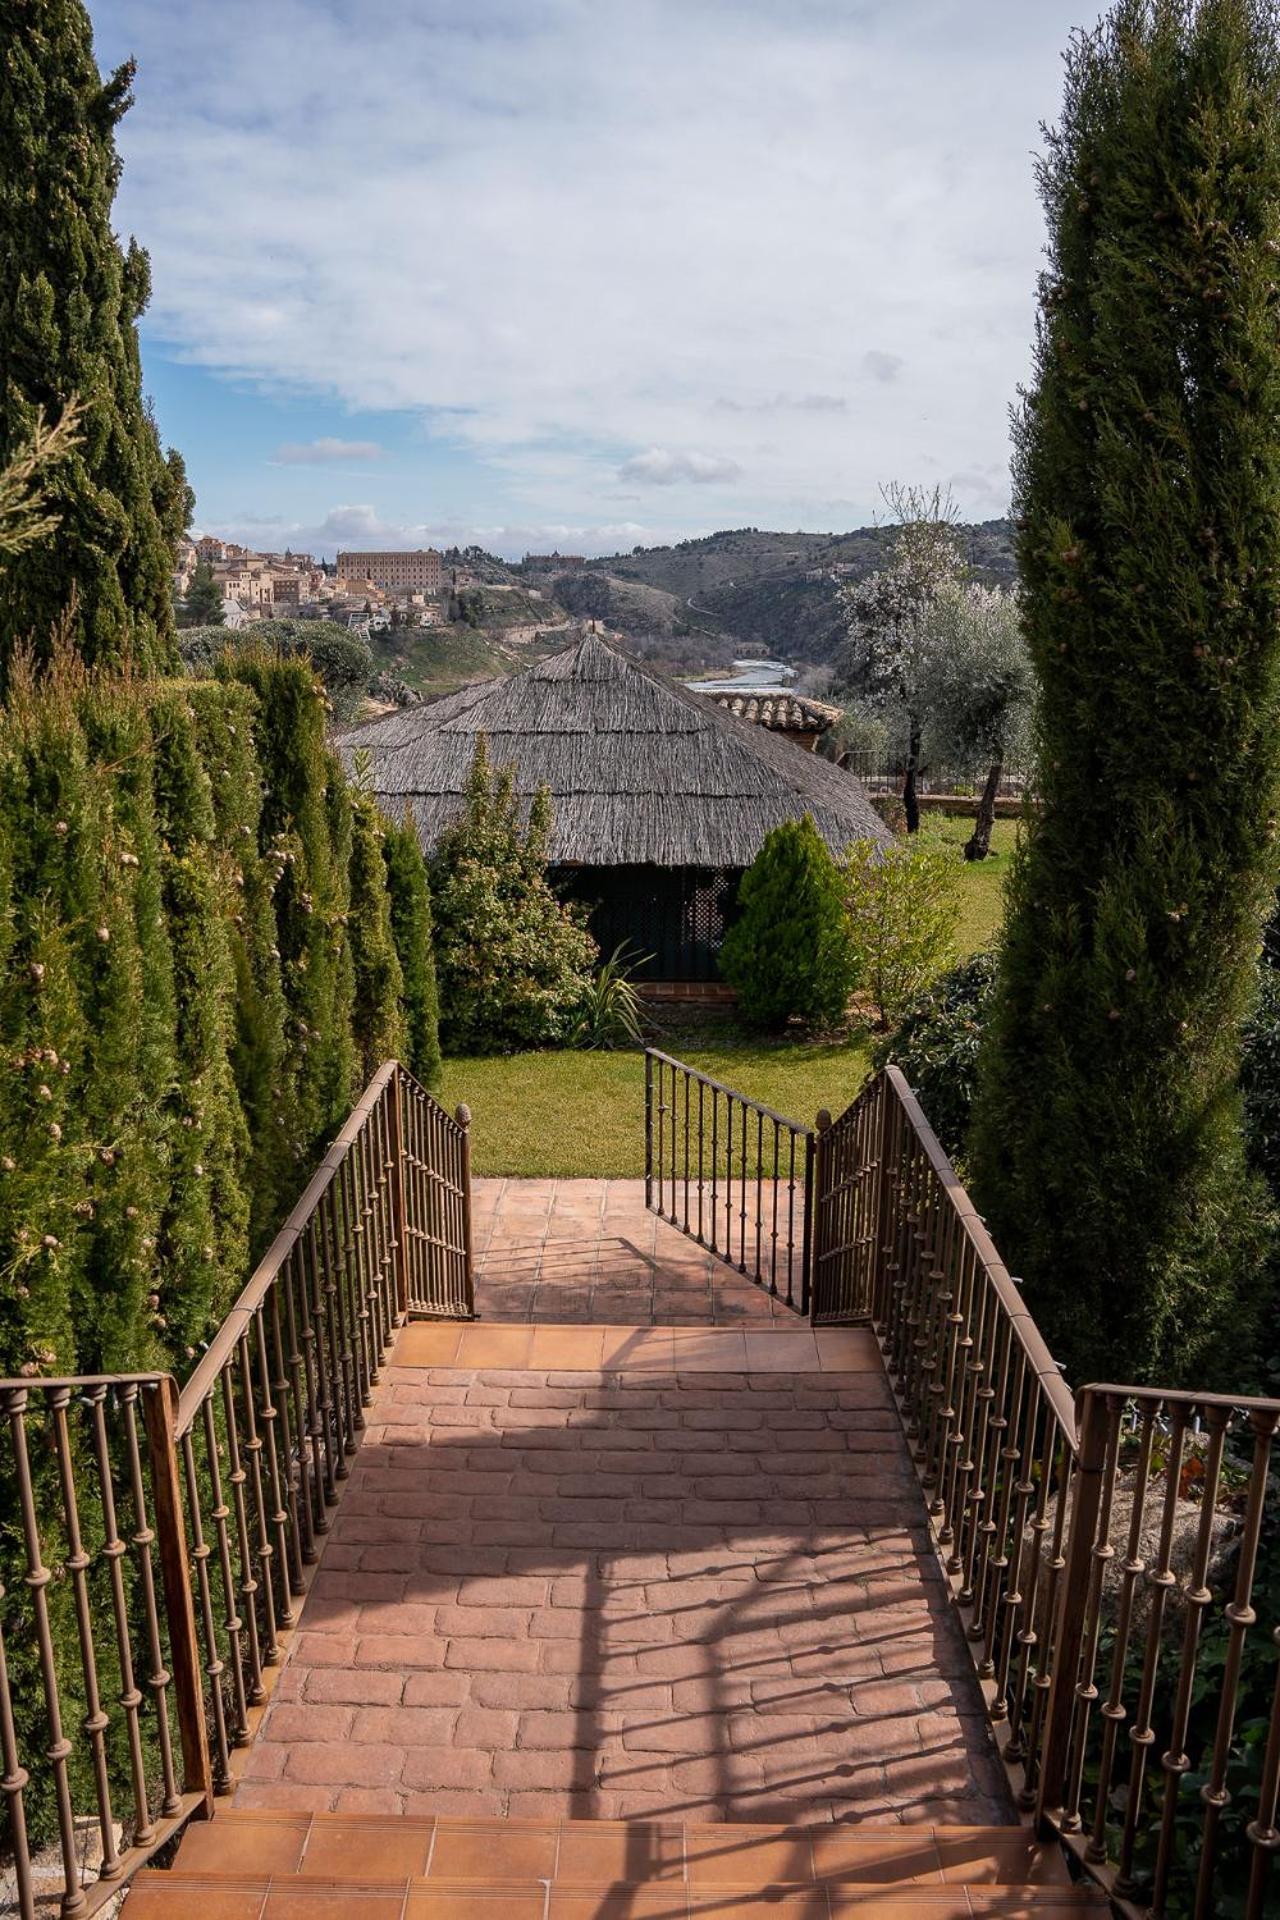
<box><xmin>472</xmin><ymin>1179</ymin><xmax>800</xmax><ymax>1327</ymax></box>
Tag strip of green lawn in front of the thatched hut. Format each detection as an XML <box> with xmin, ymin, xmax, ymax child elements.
<box><xmin>441</xmin><ymin>1033</ymin><xmax>869</xmax><ymax>1179</ymax></box>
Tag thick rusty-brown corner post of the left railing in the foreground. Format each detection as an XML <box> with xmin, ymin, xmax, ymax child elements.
<box><xmin>144</xmin><ymin>1375</ymin><xmax>213</xmax><ymax>1820</ymax></box>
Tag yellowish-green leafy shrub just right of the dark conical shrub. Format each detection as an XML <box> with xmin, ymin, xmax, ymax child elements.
<box><xmin>844</xmin><ymin>833</ymin><xmax>961</xmax><ymax>1027</ymax></box>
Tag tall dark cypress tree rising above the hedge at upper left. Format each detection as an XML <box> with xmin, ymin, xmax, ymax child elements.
<box><xmin>0</xmin><ymin>0</ymin><xmax>192</xmax><ymax>674</ymax></box>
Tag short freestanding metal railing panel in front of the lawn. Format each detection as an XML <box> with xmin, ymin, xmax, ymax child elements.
<box><xmin>645</xmin><ymin>1046</ymin><xmax>814</xmax><ymax>1313</ymax></box>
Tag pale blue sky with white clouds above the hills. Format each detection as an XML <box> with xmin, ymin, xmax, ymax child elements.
<box><xmin>90</xmin><ymin>0</ymin><xmax>1094</xmax><ymax>557</ymax></box>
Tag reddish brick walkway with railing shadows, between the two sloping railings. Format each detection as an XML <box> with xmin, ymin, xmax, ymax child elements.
<box><xmin>236</xmin><ymin>1327</ymin><xmax>1013</xmax><ymax>1824</ymax></box>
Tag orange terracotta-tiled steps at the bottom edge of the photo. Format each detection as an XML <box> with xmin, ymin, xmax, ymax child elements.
<box><xmin>125</xmin><ymin>1809</ymin><xmax>1107</xmax><ymax>1920</ymax></box>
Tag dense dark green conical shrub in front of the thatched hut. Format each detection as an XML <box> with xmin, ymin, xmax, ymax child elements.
<box><xmin>720</xmin><ymin>814</ymin><xmax>854</xmax><ymax>1031</ymax></box>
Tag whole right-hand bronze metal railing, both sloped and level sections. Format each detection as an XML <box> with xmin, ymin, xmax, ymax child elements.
<box><xmin>855</xmin><ymin>1068</ymin><xmax>1280</xmax><ymax>1920</ymax></box>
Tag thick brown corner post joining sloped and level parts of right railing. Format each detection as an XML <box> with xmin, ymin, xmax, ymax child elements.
<box><xmin>1036</xmin><ymin>1386</ymin><xmax>1111</xmax><ymax>1832</ymax></box>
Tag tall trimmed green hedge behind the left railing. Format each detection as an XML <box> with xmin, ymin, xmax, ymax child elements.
<box><xmin>0</xmin><ymin>651</ymin><xmax>438</xmax><ymax>1377</ymax></box>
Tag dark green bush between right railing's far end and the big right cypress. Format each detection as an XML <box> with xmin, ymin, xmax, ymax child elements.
<box><xmin>873</xmin><ymin>952</ymin><xmax>996</xmax><ymax>1160</ymax></box>
